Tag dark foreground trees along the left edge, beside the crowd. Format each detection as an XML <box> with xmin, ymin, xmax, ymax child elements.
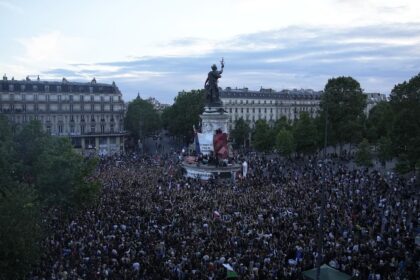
<box><xmin>0</xmin><ymin>117</ymin><xmax>100</xmax><ymax>279</ymax></box>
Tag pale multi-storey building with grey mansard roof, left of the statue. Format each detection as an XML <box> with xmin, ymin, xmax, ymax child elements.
<box><xmin>0</xmin><ymin>75</ymin><xmax>126</xmax><ymax>155</ymax></box>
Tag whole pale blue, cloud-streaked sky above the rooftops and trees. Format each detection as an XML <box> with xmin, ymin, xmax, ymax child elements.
<box><xmin>0</xmin><ymin>0</ymin><xmax>420</xmax><ymax>103</ymax></box>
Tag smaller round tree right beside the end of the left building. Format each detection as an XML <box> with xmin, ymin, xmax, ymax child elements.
<box><xmin>124</xmin><ymin>97</ymin><xmax>160</xmax><ymax>139</ymax></box>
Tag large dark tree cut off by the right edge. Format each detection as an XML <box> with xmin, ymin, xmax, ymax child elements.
<box><xmin>390</xmin><ymin>74</ymin><xmax>420</xmax><ymax>170</ymax></box>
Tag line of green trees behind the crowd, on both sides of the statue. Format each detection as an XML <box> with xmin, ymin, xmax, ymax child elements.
<box><xmin>125</xmin><ymin>74</ymin><xmax>420</xmax><ymax>172</ymax></box>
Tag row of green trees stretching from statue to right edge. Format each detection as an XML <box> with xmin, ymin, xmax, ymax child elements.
<box><xmin>231</xmin><ymin>74</ymin><xmax>420</xmax><ymax>172</ymax></box>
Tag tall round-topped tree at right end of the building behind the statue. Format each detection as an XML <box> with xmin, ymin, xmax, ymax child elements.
<box><xmin>320</xmin><ymin>77</ymin><xmax>366</xmax><ymax>150</ymax></box>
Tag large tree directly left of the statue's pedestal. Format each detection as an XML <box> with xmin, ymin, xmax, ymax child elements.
<box><xmin>162</xmin><ymin>90</ymin><xmax>204</xmax><ymax>141</ymax></box>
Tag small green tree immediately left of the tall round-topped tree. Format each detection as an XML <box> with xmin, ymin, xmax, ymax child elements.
<box><xmin>293</xmin><ymin>112</ymin><xmax>318</xmax><ymax>154</ymax></box>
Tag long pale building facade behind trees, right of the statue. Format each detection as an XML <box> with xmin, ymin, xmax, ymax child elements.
<box><xmin>220</xmin><ymin>87</ymin><xmax>322</xmax><ymax>129</ymax></box>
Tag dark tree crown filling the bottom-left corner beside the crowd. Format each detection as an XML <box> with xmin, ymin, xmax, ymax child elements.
<box><xmin>0</xmin><ymin>184</ymin><xmax>42</xmax><ymax>279</ymax></box>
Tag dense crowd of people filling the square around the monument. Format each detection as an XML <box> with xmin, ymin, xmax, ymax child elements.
<box><xmin>31</xmin><ymin>156</ymin><xmax>420</xmax><ymax>280</ymax></box>
